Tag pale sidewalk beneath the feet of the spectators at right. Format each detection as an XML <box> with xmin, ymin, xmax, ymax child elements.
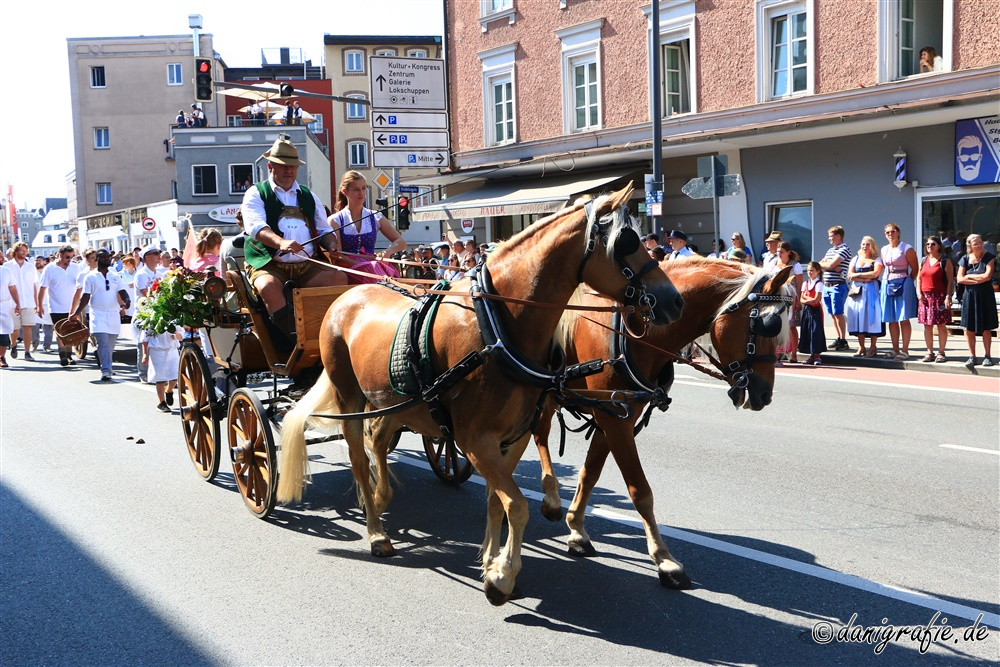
<box><xmin>816</xmin><ymin>320</ymin><xmax>1000</xmax><ymax>378</ymax></box>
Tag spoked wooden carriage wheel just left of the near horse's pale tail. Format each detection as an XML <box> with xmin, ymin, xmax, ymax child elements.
<box><xmin>228</xmin><ymin>388</ymin><xmax>278</xmax><ymax>519</ymax></box>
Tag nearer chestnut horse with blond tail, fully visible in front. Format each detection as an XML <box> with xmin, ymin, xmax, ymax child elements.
<box><xmin>277</xmin><ymin>185</ymin><xmax>683</xmax><ymax>605</ymax></box>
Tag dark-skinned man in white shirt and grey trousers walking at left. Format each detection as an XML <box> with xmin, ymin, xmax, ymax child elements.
<box><xmin>70</xmin><ymin>248</ymin><xmax>130</xmax><ymax>382</ymax></box>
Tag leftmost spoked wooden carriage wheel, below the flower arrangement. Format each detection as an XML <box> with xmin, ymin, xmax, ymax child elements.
<box><xmin>177</xmin><ymin>345</ymin><xmax>219</xmax><ymax>482</ymax></box>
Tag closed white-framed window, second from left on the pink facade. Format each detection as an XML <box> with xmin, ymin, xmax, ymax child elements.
<box><xmin>556</xmin><ymin>19</ymin><xmax>604</xmax><ymax>133</ymax></box>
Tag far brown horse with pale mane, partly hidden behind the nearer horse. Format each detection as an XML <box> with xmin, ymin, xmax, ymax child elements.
<box><xmin>534</xmin><ymin>258</ymin><xmax>791</xmax><ymax>588</ymax></box>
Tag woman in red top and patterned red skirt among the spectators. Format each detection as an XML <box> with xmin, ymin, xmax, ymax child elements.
<box><xmin>917</xmin><ymin>236</ymin><xmax>955</xmax><ymax>363</ymax></box>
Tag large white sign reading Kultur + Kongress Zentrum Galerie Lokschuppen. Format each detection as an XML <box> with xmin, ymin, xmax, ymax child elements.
<box><xmin>369</xmin><ymin>56</ymin><xmax>448</xmax><ymax>115</ymax></box>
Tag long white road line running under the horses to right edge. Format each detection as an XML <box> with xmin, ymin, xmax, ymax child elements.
<box><xmin>390</xmin><ymin>452</ymin><xmax>1000</xmax><ymax>628</ymax></box>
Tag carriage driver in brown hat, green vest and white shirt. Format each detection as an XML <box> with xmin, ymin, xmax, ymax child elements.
<box><xmin>240</xmin><ymin>134</ymin><xmax>347</xmax><ymax>344</ymax></box>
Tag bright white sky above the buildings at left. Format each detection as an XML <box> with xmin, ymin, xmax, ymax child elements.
<box><xmin>0</xmin><ymin>0</ymin><xmax>446</xmax><ymax>208</ymax></box>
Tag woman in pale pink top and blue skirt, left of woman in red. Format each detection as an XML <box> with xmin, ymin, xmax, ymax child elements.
<box><xmin>880</xmin><ymin>222</ymin><xmax>918</xmax><ymax>361</ymax></box>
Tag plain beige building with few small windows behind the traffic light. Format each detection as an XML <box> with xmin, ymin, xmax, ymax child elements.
<box><xmin>67</xmin><ymin>34</ymin><xmax>219</xmax><ymax>218</ymax></box>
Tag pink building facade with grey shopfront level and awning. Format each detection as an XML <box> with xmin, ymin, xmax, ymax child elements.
<box><xmin>424</xmin><ymin>0</ymin><xmax>1000</xmax><ymax>258</ymax></box>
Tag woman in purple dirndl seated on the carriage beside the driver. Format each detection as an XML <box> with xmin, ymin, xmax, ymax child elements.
<box><xmin>328</xmin><ymin>171</ymin><xmax>406</xmax><ymax>285</ymax></box>
